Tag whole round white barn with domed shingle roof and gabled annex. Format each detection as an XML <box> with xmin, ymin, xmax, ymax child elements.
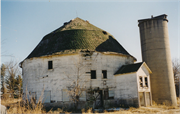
<box><xmin>20</xmin><ymin>18</ymin><xmax>152</xmax><ymax>107</ymax></box>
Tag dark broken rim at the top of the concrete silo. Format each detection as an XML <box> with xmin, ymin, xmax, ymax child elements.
<box><xmin>138</xmin><ymin>14</ymin><xmax>168</xmax><ymax>24</ymax></box>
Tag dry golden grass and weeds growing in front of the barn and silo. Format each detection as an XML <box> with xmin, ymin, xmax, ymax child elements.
<box><xmin>1</xmin><ymin>98</ymin><xmax>180</xmax><ymax>114</ymax></box>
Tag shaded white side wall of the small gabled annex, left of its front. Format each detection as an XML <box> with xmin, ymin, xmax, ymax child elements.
<box><xmin>115</xmin><ymin>73</ymin><xmax>138</xmax><ymax>107</ymax></box>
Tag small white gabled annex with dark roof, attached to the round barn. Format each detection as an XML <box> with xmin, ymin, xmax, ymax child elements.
<box><xmin>114</xmin><ymin>62</ymin><xmax>152</xmax><ymax>107</ymax></box>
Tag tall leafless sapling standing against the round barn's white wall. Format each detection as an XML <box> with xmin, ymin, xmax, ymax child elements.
<box><xmin>64</xmin><ymin>50</ymin><xmax>96</xmax><ymax>110</ymax></box>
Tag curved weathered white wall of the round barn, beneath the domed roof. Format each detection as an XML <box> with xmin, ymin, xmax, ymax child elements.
<box><xmin>22</xmin><ymin>52</ymin><xmax>134</xmax><ymax>102</ymax></box>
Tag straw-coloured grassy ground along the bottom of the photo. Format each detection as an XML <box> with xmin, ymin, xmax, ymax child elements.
<box><xmin>1</xmin><ymin>98</ymin><xmax>180</xmax><ymax>114</ymax></box>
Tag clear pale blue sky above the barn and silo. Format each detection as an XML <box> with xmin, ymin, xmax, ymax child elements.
<box><xmin>0</xmin><ymin>0</ymin><xmax>180</xmax><ymax>63</ymax></box>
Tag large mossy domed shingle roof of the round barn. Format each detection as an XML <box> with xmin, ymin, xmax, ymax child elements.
<box><xmin>27</xmin><ymin>18</ymin><xmax>135</xmax><ymax>59</ymax></box>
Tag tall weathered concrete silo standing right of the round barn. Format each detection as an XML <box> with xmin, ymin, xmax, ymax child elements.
<box><xmin>138</xmin><ymin>14</ymin><xmax>177</xmax><ymax>106</ymax></box>
